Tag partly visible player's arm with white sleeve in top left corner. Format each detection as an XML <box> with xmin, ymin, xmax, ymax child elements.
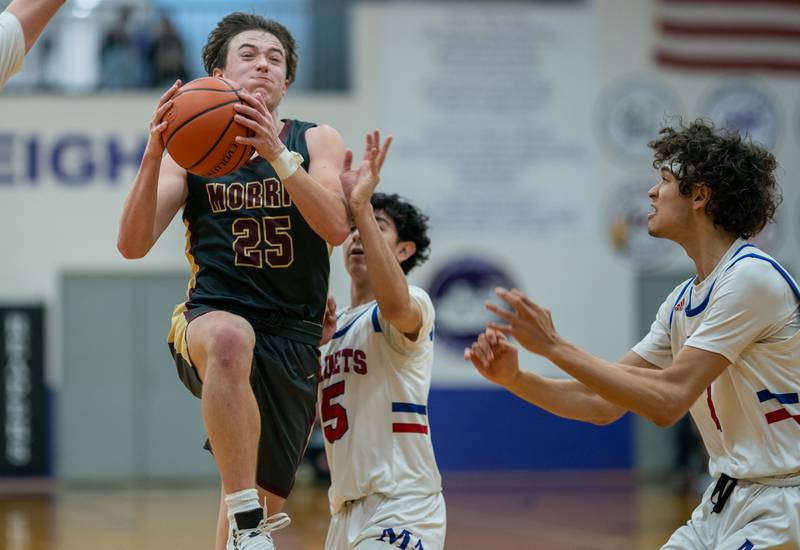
<box><xmin>0</xmin><ymin>0</ymin><xmax>64</xmax><ymax>89</ymax></box>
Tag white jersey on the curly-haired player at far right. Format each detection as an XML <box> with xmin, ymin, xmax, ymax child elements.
<box><xmin>633</xmin><ymin>240</ymin><xmax>800</xmax><ymax>479</ymax></box>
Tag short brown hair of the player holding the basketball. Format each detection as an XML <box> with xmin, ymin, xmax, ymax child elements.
<box><xmin>203</xmin><ymin>11</ymin><xmax>298</xmax><ymax>84</ymax></box>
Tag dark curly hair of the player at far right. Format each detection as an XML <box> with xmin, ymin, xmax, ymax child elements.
<box><xmin>647</xmin><ymin>119</ymin><xmax>782</xmax><ymax>239</ymax></box>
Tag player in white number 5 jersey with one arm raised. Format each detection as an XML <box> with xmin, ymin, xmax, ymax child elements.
<box><xmin>319</xmin><ymin>132</ymin><xmax>445</xmax><ymax>550</ymax></box>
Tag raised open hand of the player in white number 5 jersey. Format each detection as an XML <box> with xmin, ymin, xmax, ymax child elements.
<box><xmin>339</xmin><ymin>130</ymin><xmax>392</xmax><ymax>212</ymax></box>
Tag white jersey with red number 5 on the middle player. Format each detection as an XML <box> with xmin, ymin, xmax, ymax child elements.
<box><xmin>319</xmin><ymin>286</ymin><xmax>442</xmax><ymax>514</ymax></box>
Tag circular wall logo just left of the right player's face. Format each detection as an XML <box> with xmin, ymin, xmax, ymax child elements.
<box><xmin>606</xmin><ymin>181</ymin><xmax>680</xmax><ymax>271</ymax></box>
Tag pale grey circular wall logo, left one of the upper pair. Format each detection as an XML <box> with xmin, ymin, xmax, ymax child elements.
<box><xmin>598</xmin><ymin>80</ymin><xmax>680</xmax><ymax>162</ymax></box>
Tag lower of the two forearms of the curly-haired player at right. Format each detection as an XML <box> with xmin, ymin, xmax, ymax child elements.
<box><xmin>506</xmin><ymin>371</ymin><xmax>626</xmax><ymax>425</ymax></box>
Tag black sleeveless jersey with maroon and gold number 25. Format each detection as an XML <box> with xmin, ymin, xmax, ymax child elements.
<box><xmin>183</xmin><ymin>120</ymin><xmax>330</xmax><ymax>338</ymax></box>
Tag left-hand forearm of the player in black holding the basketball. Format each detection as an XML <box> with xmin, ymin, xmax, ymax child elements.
<box><xmin>117</xmin><ymin>155</ymin><xmax>161</xmax><ymax>259</ymax></box>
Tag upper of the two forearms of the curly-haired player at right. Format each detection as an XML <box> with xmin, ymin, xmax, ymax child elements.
<box><xmin>547</xmin><ymin>341</ymin><xmax>681</xmax><ymax>426</ymax></box>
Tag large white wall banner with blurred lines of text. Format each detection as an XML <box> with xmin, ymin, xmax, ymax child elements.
<box><xmin>372</xmin><ymin>3</ymin><xmax>595</xmax><ymax>234</ymax></box>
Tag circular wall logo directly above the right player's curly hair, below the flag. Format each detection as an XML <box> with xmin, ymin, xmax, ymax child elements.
<box><xmin>703</xmin><ymin>83</ymin><xmax>781</xmax><ymax>149</ymax></box>
